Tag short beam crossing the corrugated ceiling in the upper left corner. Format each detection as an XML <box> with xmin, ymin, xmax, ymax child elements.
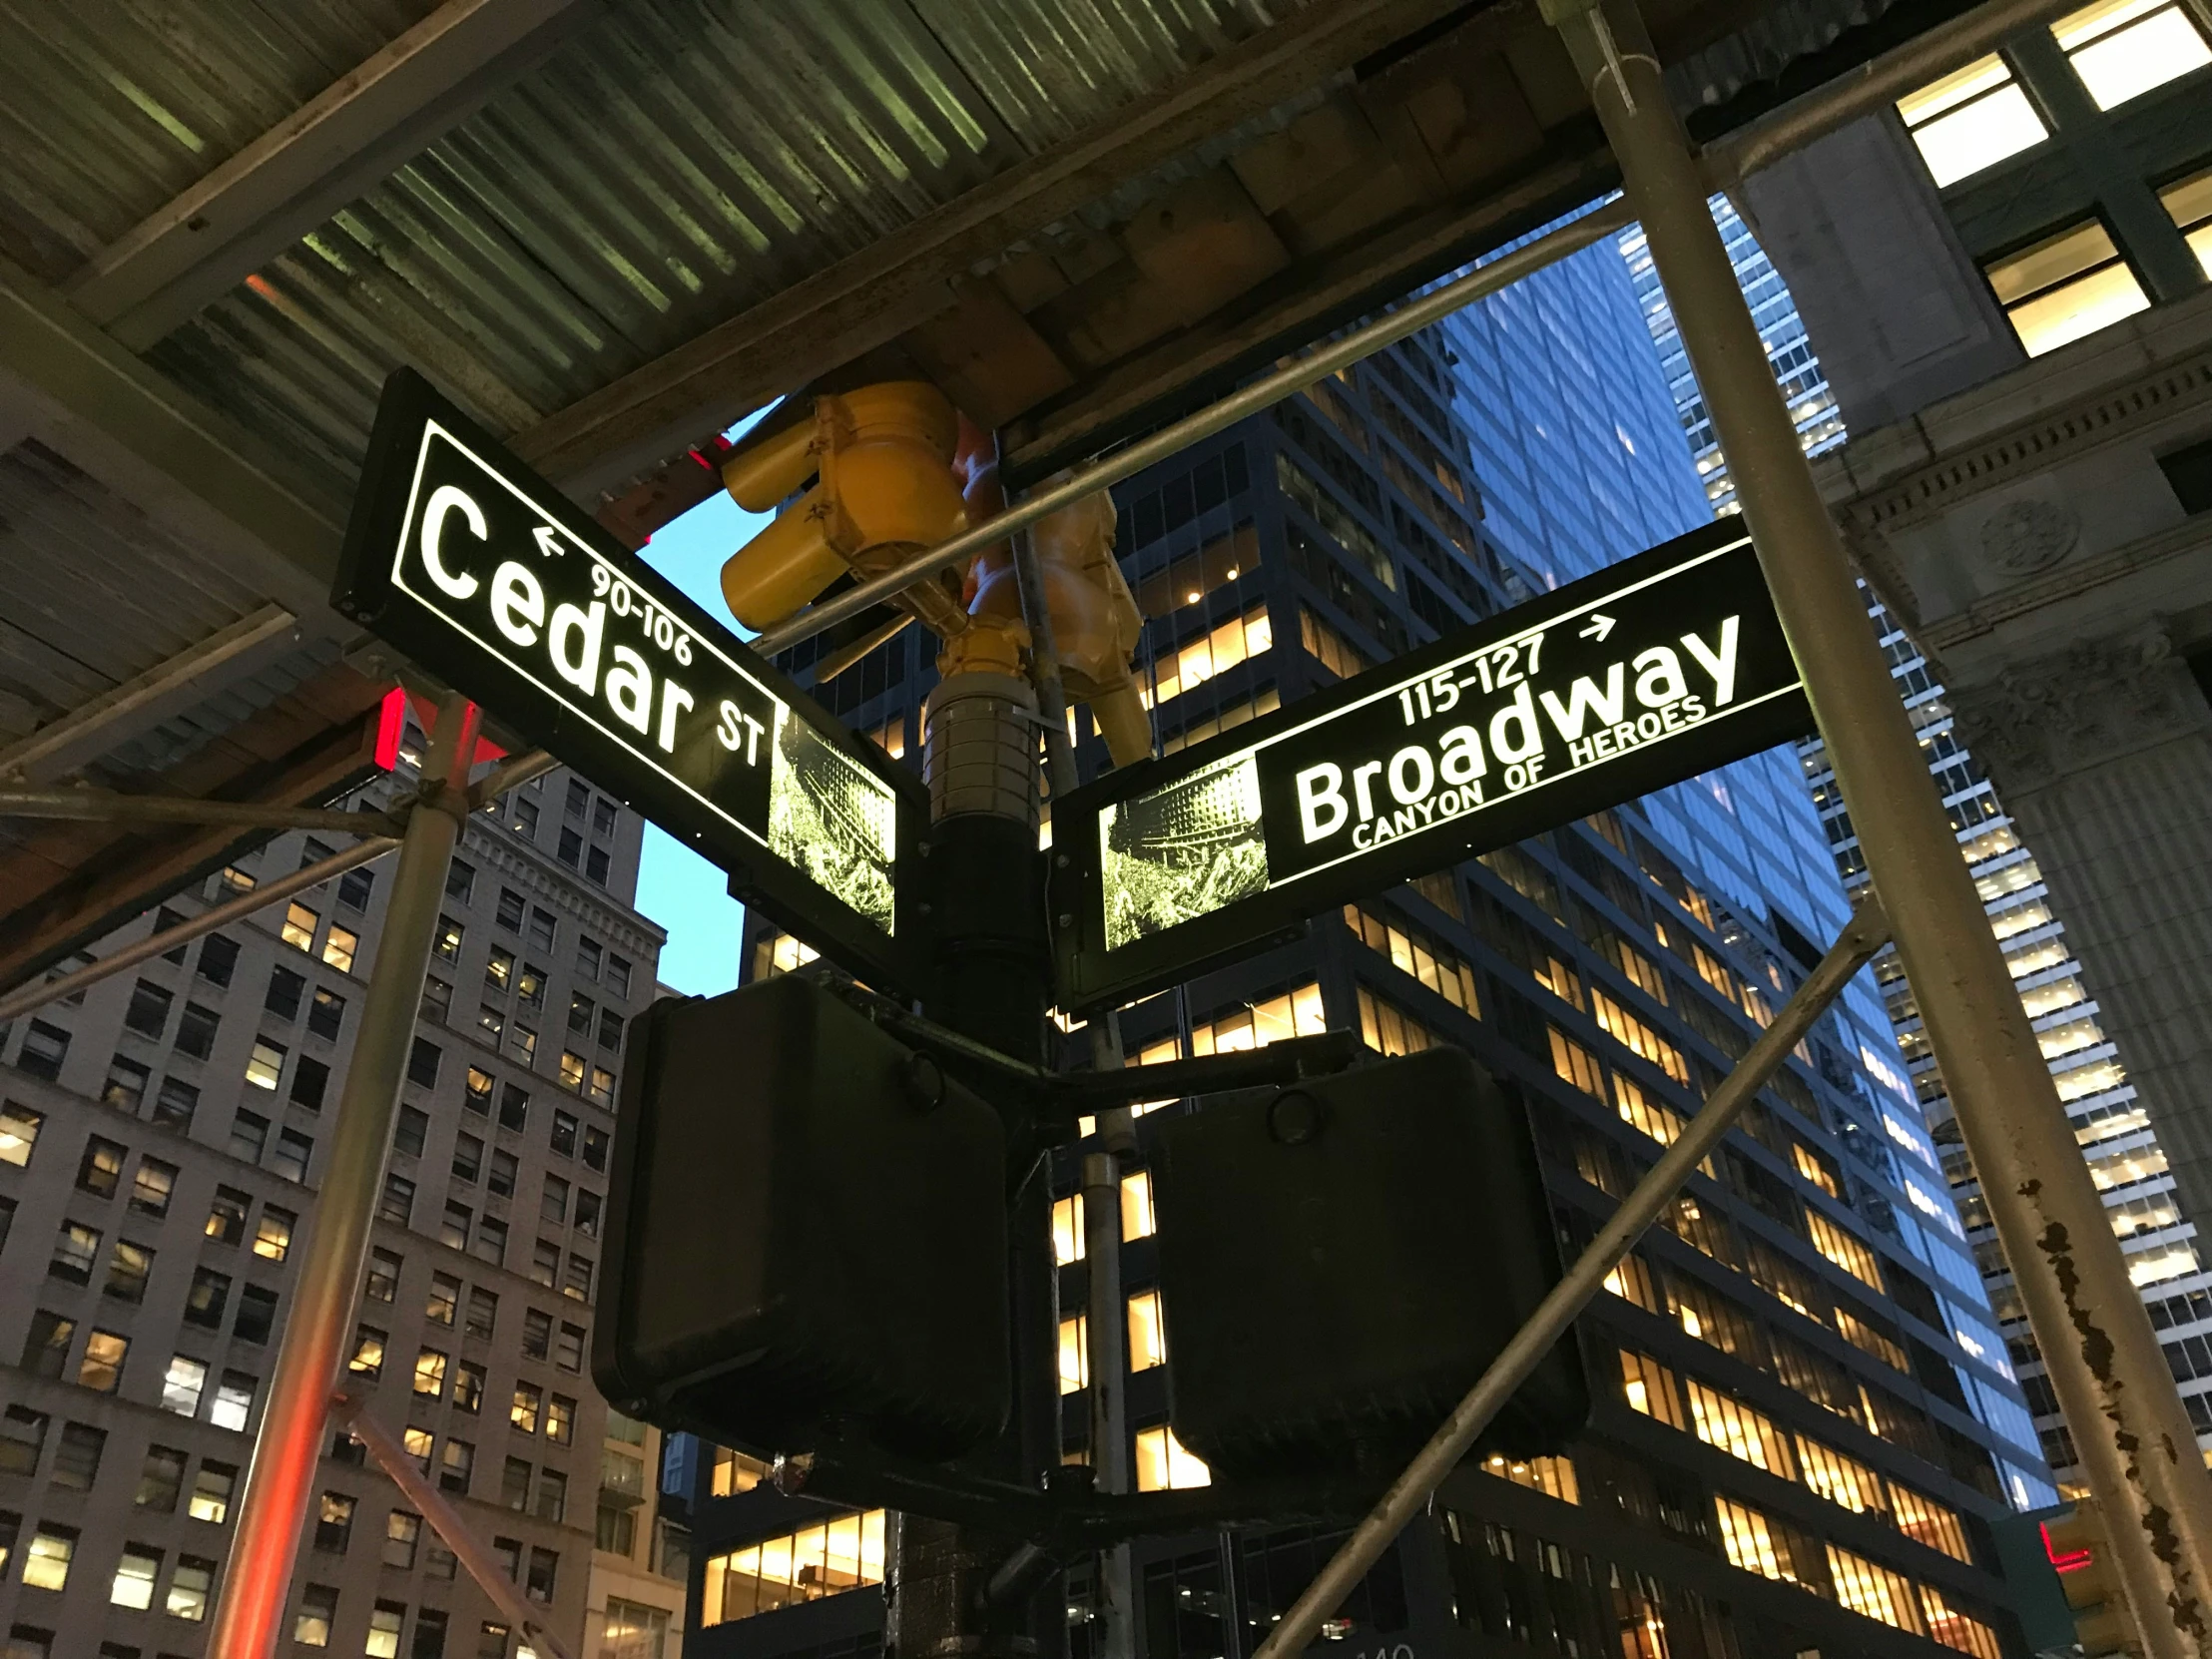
<box><xmin>69</xmin><ymin>0</ymin><xmax>604</xmax><ymax>351</ymax></box>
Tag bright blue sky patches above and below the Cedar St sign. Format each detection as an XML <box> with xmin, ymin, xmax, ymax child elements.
<box><xmin>637</xmin><ymin>455</ymin><xmax>775</xmax><ymax>995</ymax></box>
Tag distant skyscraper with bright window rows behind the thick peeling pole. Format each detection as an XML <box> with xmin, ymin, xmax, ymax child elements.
<box><xmin>1619</xmin><ymin>197</ymin><xmax>2212</xmax><ymax>1488</ymax></box>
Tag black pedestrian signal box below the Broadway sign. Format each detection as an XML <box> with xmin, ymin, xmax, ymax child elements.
<box><xmin>1153</xmin><ymin>1048</ymin><xmax>1590</xmax><ymax>1480</ymax></box>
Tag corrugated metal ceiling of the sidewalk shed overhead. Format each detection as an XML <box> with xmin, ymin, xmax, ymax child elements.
<box><xmin>0</xmin><ymin>0</ymin><xmax>1301</xmax><ymax>506</ymax></box>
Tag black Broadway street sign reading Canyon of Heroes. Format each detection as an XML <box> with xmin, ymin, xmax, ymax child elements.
<box><xmin>1053</xmin><ymin>520</ymin><xmax>1812</xmax><ymax>1008</ymax></box>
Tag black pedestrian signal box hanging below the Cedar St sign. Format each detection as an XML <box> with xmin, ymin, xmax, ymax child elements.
<box><xmin>593</xmin><ymin>975</ymin><xmax>1011</xmax><ymax>1457</ymax></box>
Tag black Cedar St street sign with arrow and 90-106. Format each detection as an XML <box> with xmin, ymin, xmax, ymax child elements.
<box><xmin>331</xmin><ymin>369</ymin><xmax>929</xmax><ymax>991</ymax></box>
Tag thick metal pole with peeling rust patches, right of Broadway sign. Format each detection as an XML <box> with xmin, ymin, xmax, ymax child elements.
<box><xmin>1544</xmin><ymin>0</ymin><xmax>2212</xmax><ymax>1659</ymax></box>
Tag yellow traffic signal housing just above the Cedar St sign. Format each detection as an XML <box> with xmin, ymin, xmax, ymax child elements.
<box><xmin>721</xmin><ymin>380</ymin><xmax>966</xmax><ymax>635</ymax></box>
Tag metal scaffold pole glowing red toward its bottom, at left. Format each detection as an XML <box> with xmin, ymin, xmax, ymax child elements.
<box><xmin>208</xmin><ymin>697</ymin><xmax>478</xmax><ymax>1659</ymax></box>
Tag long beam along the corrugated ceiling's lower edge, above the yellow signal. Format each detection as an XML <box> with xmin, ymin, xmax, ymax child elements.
<box><xmin>513</xmin><ymin>0</ymin><xmax>1457</xmax><ymax>498</ymax></box>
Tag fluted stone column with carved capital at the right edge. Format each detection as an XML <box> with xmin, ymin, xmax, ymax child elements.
<box><xmin>1948</xmin><ymin>622</ymin><xmax>2212</xmax><ymax>1250</ymax></box>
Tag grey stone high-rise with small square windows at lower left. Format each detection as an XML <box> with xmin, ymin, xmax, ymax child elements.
<box><xmin>0</xmin><ymin>726</ymin><xmax>662</xmax><ymax>1659</ymax></box>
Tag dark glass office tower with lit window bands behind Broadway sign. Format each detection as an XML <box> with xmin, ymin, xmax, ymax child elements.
<box><xmin>686</xmin><ymin>231</ymin><xmax>2050</xmax><ymax>1659</ymax></box>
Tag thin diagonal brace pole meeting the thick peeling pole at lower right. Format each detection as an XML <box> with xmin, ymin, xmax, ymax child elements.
<box><xmin>1252</xmin><ymin>898</ymin><xmax>1889</xmax><ymax>1659</ymax></box>
